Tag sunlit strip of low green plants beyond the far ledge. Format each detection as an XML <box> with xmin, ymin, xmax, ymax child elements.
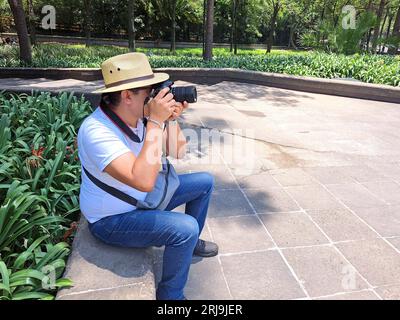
<box><xmin>0</xmin><ymin>44</ymin><xmax>400</xmax><ymax>86</ymax></box>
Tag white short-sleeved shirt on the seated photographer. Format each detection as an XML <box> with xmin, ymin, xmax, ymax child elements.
<box><xmin>78</xmin><ymin>108</ymin><xmax>147</xmax><ymax>223</ymax></box>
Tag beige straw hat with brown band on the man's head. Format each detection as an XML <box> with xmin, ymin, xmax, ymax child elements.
<box><xmin>93</xmin><ymin>52</ymin><xmax>169</xmax><ymax>93</ymax></box>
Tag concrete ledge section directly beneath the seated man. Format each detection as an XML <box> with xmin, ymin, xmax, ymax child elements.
<box><xmin>56</xmin><ymin>216</ymin><xmax>155</xmax><ymax>300</ymax></box>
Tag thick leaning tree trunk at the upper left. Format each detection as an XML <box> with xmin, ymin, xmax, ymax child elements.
<box><xmin>8</xmin><ymin>0</ymin><xmax>32</xmax><ymax>64</ymax></box>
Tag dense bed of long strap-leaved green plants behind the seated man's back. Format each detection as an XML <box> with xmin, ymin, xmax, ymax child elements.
<box><xmin>0</xmin><ymin>93</ymin><xmax>91</xmax><ymax>300</ymax></box>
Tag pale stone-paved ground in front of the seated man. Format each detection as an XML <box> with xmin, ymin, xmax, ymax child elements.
<box><xmin>154</xmin><ymin>82</ymin><xmax>400</xmax><ymax>299</ymax></box>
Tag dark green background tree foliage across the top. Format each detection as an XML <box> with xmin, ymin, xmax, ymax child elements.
<box><xmin>0</xmin><ymin>0</ymin><xmax>400</xmax><ymax>58</ymax></box>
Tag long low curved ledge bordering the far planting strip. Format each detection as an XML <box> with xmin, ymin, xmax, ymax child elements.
<box><xmin>0</xmin><ymin>68</ymin><xmax>400</xmax><ymax>103</ymax></box>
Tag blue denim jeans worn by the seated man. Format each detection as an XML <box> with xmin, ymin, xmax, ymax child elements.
<box><xmin>89</xmin><ymin>172</ymin><xmax>214</xmax><ymax>300</ymax></box>
